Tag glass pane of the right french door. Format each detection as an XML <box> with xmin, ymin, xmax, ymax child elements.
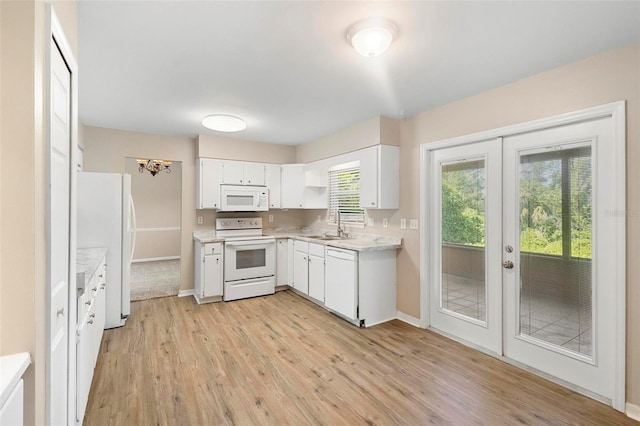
<box><xmin>519</xmin><ymin>147</ymin><xmax>593</xmax><ymax>357</ymax></box>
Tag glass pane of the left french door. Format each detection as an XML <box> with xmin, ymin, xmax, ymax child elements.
<box><xmin>440</xmin><ymin>160</ymin><xmax>486</xmax><ymax>322</ymax></box>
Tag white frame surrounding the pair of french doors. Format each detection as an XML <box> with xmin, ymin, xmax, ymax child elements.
<box><xmin>420</xmin><ymin>101</ymin><xmax>626</xmax><ymax>412</ymax></box>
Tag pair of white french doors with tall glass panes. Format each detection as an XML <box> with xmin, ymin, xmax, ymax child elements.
<box><xmin>428</xmin><ymin>108</ymin><xmax>624</xmax><ymax>409</ymax></box>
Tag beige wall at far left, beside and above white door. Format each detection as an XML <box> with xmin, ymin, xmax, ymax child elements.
<box><xmin>0</xmin><ymin>0</ymin><xmax>77</xmax><ymax>424</ymax></box>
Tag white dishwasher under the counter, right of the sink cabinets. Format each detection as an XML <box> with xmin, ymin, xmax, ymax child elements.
<box><xmin>324</xmin><ymin>247</ymin><xmax>359</xmax><ymax>321</ymax></box>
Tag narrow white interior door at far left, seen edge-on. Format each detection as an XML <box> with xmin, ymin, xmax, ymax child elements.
<box><xmin>46</xmin><ymin>39</ymin><xmax>71</xmax><ymax>425</ymax></box>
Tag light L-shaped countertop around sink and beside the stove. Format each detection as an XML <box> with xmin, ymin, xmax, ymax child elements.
<box><xmin>193</xmin><ymin>228</ymin><xmax>402</xmax><ymax>251</ymax></box>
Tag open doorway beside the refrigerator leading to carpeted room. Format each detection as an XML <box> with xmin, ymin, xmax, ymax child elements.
<box><xmin>125</xmin><ymin>158</ymin><xmax>182</xmax><ymax>302</ymax></box>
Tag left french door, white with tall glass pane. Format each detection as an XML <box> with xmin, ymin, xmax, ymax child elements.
<box><xmin>429</xmin><ymin>140</ymin><xmax>502</xmax><ymax>354</ymax></box>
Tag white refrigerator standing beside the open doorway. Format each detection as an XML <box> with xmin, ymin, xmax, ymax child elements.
<box><xmin>77</xmin><ymin>172</ymin><xmax>136</xmax><ymax>329</ymax></box>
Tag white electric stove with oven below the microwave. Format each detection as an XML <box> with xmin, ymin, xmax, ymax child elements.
<box><xmin>216</xmin><ymin>218</ymin><xmax>276</xmax><ymax>302</ymax></box>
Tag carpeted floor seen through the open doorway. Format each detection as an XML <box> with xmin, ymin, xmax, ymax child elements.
<box><xmin>131</xmin><ymin>259</ymin><xmax>180</xmax><ymax>302</ymax></box>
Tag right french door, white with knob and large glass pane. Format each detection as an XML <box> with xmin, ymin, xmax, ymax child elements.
<box><xmin>503</xmin><ymin>118</ymin><xmax>616</xmax><ymax>399</ymax></box>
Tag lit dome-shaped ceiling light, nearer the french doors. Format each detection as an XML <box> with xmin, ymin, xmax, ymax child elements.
<box><xmin>347</xmin><ymin>18</ymin><xmax>398</xmax><ymax>58</ymax></box>
